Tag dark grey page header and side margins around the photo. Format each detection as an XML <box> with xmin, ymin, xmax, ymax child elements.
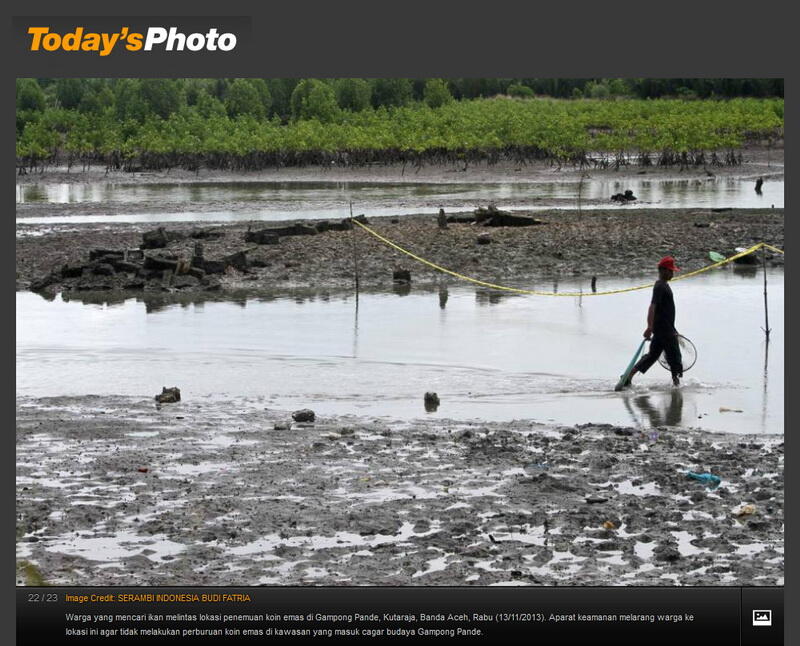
<box><xmin>6</xmin><ymin>0</ymin><xmax>800</xmax><ymax>643</ymax></box>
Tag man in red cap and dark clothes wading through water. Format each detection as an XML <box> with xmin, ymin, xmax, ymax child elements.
<box><xmin>617</xmin><ymin>256</ymin><xmax>683</xmax><ymax>390</ymax></box>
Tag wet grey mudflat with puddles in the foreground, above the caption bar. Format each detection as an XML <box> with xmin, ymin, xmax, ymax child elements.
<box><xmin>17</xmin><ymin>397</ymin><xmax>783</xmax><ymax>585</ymax></box>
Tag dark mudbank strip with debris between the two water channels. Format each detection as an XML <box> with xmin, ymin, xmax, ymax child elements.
<box><xmin>16</xmin><ymin>207</ymin><xmax>784</xmax><ymax>293</ymax></box>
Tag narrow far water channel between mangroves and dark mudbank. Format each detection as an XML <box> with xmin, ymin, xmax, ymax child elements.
<box><xmin>16</xmin><ymin>177</ymin><xmax>784</xmax><ymax>224</ymax></box>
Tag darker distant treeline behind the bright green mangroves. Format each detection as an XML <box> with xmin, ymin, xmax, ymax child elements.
<box><xmin>16</xmin><ymin>78</ymin><xmax>783</xmax><ymax>126</ymax></box>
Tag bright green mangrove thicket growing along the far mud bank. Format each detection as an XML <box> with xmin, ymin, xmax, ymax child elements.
<box><xmin>16</xmin><ymin>95</ymin><xmax>784</xmax><ymax>172</ymax></box>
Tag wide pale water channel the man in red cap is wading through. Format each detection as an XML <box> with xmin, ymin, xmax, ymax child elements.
<box><xmin>16</xmin><ymin>268</ymin><xmax>784</xmax><ymax>433</ymax></box>
